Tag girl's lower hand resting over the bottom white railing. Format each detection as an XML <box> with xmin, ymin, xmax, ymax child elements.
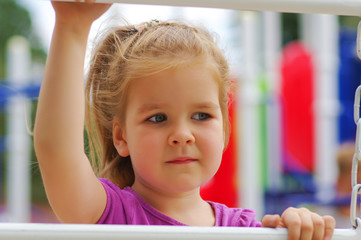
<box><xmin>262</xmin><ymin>207</ymin><xmax>336</xmax><ymax>240</ymax></box>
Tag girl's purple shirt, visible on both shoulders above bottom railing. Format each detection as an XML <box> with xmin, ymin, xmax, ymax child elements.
<box><xmin>98</xmin><ymin>178</ymin><xmax>261</xmax><ymax>227</ymax></box>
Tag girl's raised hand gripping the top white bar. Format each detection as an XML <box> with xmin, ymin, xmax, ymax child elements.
<box><xmin>52</xmin><ymin>0</ymin><xmax>111</xmax><ymax>30</ymax></box>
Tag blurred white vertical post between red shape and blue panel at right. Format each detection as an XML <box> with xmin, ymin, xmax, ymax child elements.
<box><xmin>303</xmin><ymin>15</ymin><xmax>339</xmax><ymax>202</ymax></box>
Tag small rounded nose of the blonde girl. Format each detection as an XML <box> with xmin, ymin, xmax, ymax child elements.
<box><xmin>168</xmin><ymin>123</ymin><xmax>195</xmax><ymax>146</ymax></box>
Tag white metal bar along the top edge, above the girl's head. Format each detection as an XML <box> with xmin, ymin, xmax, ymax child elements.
<box><xmin>68</xmin><ymin>0</ymin><xmax>361</xmax><ymax>16</ymax></box>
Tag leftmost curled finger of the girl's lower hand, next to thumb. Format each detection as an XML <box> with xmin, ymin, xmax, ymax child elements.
<box><xmin>281</xmin><ymin>208</ymin><xmax>301</xmax><ymax>240</ymax></box>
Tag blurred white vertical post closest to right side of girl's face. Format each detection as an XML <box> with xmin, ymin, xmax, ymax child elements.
<box><xmin>238</xmin><ymin>12</ymin><xmax>264</xmax><ymax>217</ymax></box>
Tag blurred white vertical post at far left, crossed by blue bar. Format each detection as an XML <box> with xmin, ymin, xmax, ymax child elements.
<box><xmin>6</xmin><ymin>37</ymin><xmax>31</xmax><ymax>222</ymax></box>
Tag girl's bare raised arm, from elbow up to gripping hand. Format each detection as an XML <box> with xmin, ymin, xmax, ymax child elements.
<box><xmin>34</xmin><ymin>2</ymin><xmax>110</xmax><ymax>223</ymax></box>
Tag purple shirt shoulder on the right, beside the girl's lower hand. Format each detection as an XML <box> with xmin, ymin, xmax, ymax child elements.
<box><xmin>209</xmin><ymin>202</ymin><xmax>261</xmax><ymax>227</ymax></box>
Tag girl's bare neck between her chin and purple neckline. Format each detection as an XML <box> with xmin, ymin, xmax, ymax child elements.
<box><xmin>132</xmin><ymin>182</ymin><xmax>215</xmax><ymax>226</ymax></box>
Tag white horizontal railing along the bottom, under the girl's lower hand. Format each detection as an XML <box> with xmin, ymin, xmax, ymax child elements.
<box><xmin>0</xmin><ymin>223</ymin><xmax>361</xmax><ymax>240</ymax></box>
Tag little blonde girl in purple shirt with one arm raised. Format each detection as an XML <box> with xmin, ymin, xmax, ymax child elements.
<box><xmin>34</xmin><ymin>2</ymin><xmax>335</xmax><ymax>239</ymax></box>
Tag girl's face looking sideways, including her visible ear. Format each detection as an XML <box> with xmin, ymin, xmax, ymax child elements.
<box><xmin>113</xmin><ymin>64</ymin><xmax>224</xmax><ymax>193</ymax></box>
